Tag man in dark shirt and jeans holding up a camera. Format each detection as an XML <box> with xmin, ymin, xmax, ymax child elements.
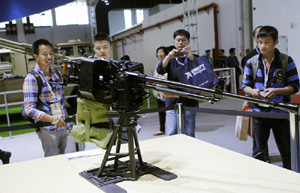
<box><xmin>157</xmin><ymin>29</ymin><xmax>198</xmax><ymax>137</ymax></box>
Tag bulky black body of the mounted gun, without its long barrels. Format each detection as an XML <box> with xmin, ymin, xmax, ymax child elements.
<box><xmin>63</xmin><ymin>58</ymin><xmax>148</xmax><ymax>111</ymax></box>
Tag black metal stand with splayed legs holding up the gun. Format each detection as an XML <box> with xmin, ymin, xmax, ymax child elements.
<box><xmin>80</xmin><ymin>111</ymin><xmax>177</xmax><ymax>192</ymax></box>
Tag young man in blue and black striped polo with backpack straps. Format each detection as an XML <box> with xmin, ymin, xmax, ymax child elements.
<box><xmin>242</xmin><ymin>26</ymin><xmax>299</xmax><ymax>169</ymax></box>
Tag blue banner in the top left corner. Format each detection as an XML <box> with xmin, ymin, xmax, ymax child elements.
<box><xmin>0</xmin><ymin>0</ymin><xmax>74</xmax><ymax>22</ymax></box>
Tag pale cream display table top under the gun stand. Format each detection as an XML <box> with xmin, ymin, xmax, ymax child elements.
<box><xmin>0</xmin><ymin>135</ymin><xmax>300</xmax><ymax>193</ymax></box>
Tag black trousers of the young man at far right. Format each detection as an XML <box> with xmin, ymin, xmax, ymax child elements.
<box><xmin>252</xmin><ymin>117</ymin><xmax>291</xmax><ymax>169</ymax></box>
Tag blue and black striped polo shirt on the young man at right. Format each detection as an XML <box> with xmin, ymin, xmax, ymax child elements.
<box><xmin>242</xmin><ymin>48</ymin><xmax>299</xmax><ymax>112</ymax></box>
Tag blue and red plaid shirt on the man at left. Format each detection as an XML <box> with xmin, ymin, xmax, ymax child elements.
<box><xmin>23</xmin><ymin>64</ymin><xmax>72</xmax><ymax>131</ymax></box>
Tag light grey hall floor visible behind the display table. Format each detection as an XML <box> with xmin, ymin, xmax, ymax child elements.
<box><xmin>0</xmin><ymin>99</ymin><xmax>282</xmax><ymax>166</ymax></box>
